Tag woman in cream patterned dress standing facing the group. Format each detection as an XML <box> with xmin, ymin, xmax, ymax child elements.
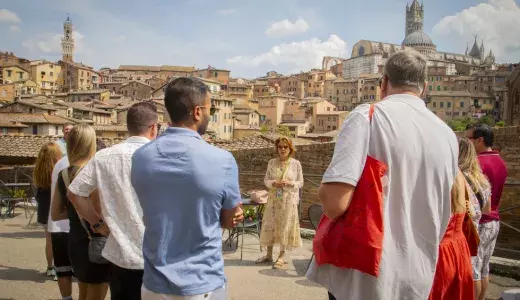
<box><xmin>256</xmin><ymin>137</ymin><xmax>303</xmax><ymax>269</ymax></box>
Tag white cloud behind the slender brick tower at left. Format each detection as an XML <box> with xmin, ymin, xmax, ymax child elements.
<box><xmin>22</xmin><ymin>31</ymin><xmax>89</xmax><ymax>54</ymax></box>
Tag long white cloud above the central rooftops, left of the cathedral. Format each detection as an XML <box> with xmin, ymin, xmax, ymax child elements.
<box><xmin>227</xmin><ymin>34</ymin><xmax>347</xmax><ymax>72</ymax></box>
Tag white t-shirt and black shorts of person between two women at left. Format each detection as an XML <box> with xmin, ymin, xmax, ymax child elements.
<box><xmin>47</xmin><ymin>156</ymin><xmax>73</xmax><ymax>300</ymax></box>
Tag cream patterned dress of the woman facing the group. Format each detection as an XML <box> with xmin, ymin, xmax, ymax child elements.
<box><xmin>260</xmin><ymin>158</ymin><xmax>303</xmax><ymax>250</ymax></box>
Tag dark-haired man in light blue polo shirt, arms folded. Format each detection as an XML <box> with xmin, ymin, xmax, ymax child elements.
<box><xmin>131</xmin><ymin>78</ymin><xmax>243</xmax><ymax>300</ymax></box>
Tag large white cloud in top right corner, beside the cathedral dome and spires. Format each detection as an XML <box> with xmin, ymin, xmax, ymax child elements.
<box><xmin>433</xmin><ymin>0</ymin><xmax>520</xmax><ymax>62</ymax></box>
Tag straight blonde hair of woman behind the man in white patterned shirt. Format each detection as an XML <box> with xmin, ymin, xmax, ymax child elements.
<box><xmin>67</xmin><ymin>124</ymin><xmax>96</xmax><ymax>167</ymax></box>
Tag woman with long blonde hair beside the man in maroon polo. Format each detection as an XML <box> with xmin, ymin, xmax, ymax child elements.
<box><xmin>459</xmin><ymin>138</ymin><xmax>494</xmax><ymax>299</ymax></box>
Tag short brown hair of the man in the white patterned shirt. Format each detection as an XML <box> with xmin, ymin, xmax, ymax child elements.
<box><xmin>126</xmin><ymin>101</ymin><xmax>158</xmax><ymax>135</ymax></box>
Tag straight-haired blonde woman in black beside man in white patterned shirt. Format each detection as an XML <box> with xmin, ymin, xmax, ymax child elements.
<box><xmin>51</xmin><ymin>124</ymin><xmax>109</xmax><ymax>300</ymax></box>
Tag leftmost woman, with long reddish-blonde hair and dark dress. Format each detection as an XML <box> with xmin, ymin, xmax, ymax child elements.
<box><xmin>33</xmin><ymin>142</ymin><xmax>61</xmax><ymax>277</ymax></box>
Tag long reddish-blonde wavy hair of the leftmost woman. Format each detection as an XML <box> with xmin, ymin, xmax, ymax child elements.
<box><xmin>33</xmin><ymin>142</ymin><xmax>61</xmax><ymax>189</ymax></box>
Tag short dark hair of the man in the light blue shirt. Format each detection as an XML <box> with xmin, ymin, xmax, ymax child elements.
<box><xmin>164</xmin><ymin>77</ymin><xmax>209</xmax><ymax>123</ymax></box>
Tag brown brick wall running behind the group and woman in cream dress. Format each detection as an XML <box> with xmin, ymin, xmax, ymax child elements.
<box><xmin>0</xmin><ymin>127</ymin><xmax>520</xmax><ymax>250</ymax></box>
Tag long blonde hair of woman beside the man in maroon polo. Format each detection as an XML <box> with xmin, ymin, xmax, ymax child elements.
<box><xmin>459</xmin><ymin>138</ymin><xmax>491</xmax><ymax>191</ymax></box>
